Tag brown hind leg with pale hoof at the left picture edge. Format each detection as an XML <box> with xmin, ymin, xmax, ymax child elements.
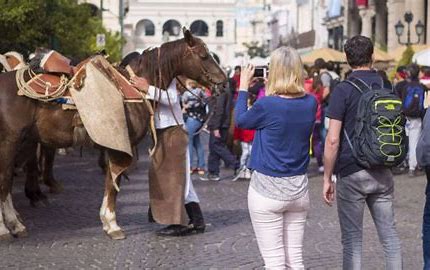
<box><xmin>0</xmin><ymin>139</ymin><xmax>27</xmax><ymax>239</ymax></box>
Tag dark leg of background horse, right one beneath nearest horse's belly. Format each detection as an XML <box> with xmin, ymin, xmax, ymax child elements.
<box><xmin>40</xmin><ymin>145</ymin><xmax>64</xmax><ymax>194</ymax></box>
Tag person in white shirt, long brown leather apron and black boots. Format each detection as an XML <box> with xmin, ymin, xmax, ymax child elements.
<box><xmin>131</xmin><ymin>77</ymin><xmax>206</xmax><ymax>236</ymax></box>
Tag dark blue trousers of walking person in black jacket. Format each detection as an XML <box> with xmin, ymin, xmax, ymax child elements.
<box><xmin>208</xmin><ymin>128</ymin><xmax>239</xmax><ymax>175</ymax></box>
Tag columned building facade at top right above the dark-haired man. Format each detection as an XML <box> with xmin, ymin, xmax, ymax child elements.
<box><xmin>324</xmin><ymin>0</ymin><xmax>430</xmax><ymax>52</ymax></box>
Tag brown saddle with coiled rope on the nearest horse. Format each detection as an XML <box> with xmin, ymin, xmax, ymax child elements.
<box><xmin>16</xmin><ymin>51</ymin><xmax>143</xmax><ymax>103</ymax></box>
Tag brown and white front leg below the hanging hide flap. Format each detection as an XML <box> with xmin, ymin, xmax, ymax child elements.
<box><xmin>100</xmin><ymin>159</ymin><xmax>125</xmax><ymax>240</ymax></box>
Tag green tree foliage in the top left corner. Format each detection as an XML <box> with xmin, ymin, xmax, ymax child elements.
<box><xmin>0</xmin><ymin>0</ymin><xmax>123</xmax><ymax>61</ymax></box>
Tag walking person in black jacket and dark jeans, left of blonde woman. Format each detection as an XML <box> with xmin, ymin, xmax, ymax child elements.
<box><xmin>200</xmin><ymin>84</ymin><xmax>239</xmax><ymax>181</ymax></box>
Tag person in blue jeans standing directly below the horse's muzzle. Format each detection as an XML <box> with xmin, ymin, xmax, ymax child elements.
<box><xmin>182</xmin><ymin>80</ymin><xmax>206</xmax><ymax>175</ymax></box>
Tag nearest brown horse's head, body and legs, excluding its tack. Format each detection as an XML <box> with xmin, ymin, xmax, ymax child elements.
<box><xmin>0</xmin><ymin>30</ymin><xmax>226</xmax><ymax>239</ymax></box>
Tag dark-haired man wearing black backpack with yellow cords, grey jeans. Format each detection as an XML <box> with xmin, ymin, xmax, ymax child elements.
<box><xmin>323</xmin><ymin>36</ymin><xmax>405</xmax><ymax>270</ymax></box>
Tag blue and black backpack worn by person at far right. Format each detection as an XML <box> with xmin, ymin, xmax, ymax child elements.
<box><xmin>403</xmin><ymin>82</ymin><xmax>425</xmax><ymax>118</ymax></box>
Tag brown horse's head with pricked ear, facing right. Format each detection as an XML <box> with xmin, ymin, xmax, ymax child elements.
<box><xmin>179</xmin><ymin>27</ymin><xmax>227</xmax><ymax>87</ymax></box>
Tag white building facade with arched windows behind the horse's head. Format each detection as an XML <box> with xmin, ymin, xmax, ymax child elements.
<box><xmin>124</xmin><ymin>0</ymin><xmax>236</xmax><ymax>64</ymax></box>
